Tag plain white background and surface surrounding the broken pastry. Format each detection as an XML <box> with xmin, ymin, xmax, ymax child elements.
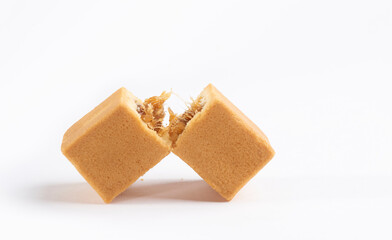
<box><xmin>0</xmin><ymin>0</ymin><xmax>392</xmax><ymax>239</ymax></box>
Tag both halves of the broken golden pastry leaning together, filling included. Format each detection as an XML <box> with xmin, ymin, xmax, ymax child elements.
<box><xmin>61</xmin><ymin>84</ymin><xmax>275</xmax><ymax>203</ymax></box>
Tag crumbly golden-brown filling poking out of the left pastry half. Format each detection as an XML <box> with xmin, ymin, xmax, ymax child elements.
<box><xmin>136</xmin><ymin>92</ymin><xmax>171</xmax><ymax>137</ymax></box>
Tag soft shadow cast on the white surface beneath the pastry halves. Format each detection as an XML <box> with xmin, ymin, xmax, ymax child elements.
<box><xmin>36</xmin><ymin>180</ymin><xmax>225</xmax><ymax>204</ymax></box>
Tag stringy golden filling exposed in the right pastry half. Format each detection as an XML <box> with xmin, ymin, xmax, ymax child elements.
<box><xmin>167</xmin><ymin>96</ymin><xmax>205</xmax><ymax>145</ymax></box>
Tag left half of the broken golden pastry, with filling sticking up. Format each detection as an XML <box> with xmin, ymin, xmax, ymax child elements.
<box><xmin>61</xmin><ymin>88</ymin><xmax>171</xmax><ymax>203</ymax></box>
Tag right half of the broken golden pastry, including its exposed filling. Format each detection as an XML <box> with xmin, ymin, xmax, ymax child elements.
<box><xmin>167</xmin><ymin>84</ymin><xmax>275</xmax><ymax>200</ymax></box>
